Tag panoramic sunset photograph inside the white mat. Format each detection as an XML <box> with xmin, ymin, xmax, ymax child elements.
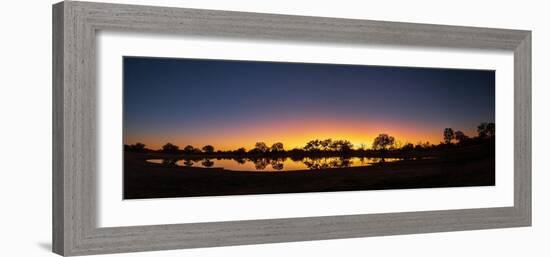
<box><xmin>123</xmin><ymin>56</ymin><xmax>495</xmax><ymax>199</ymax></box>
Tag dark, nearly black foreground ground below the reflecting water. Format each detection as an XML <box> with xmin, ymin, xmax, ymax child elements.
<box><xmin>124</xmin><ymin>152</ymin><xmax>495</xmax><ymax>199</ymax></box>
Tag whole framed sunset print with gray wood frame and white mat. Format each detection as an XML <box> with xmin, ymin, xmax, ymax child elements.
<box><xmin>53</xmin><ymin>1</ymin><xmax>531</xmax><ymax>256</ymax></box>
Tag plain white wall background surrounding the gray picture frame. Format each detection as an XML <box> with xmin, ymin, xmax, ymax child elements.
<box><xmin>0</xmin><ymin>0</ymin><xmax>550</xmax><ymax>257</ymax></box>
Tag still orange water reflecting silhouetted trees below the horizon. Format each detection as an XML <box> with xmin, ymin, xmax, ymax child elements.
<box><xmin>147</xmin><ymin>157</ymin><xmax>401</xmax><ymax>171</ymax></box>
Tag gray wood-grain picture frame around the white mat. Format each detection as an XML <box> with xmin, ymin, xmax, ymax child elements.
<box><xmin>53</xmin><ymin>1</ymin><xmax>531</xmax><ymax>256</ymax></box>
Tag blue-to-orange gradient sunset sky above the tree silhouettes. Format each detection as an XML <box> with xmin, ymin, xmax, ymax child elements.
<box><xmin>123</xmin><ymin>57</ymin><xmax>495</xmax><ymax>150</ymax></box>
